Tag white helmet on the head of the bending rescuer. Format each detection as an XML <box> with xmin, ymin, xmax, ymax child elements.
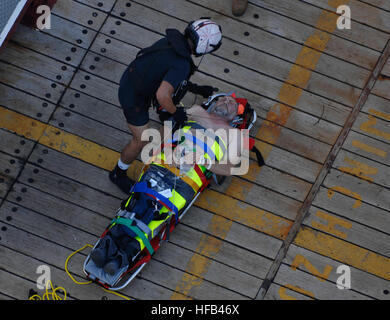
<box><xmin>184</xmin><ymin>18</ymin><xmax>222</xmax><ymax>57</ymax></box>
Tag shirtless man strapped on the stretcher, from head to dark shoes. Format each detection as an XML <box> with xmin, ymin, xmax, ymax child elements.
<box><xmin>91</xmin><ymin>96</ymin><xmax>248</xmax><ymax>275</ymax></box>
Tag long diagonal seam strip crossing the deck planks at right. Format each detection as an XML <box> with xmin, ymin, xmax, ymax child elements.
<box><xmin>256</xmin><ymin>39</ymin><xmax>390</xmax><ymax>300</ymax></box>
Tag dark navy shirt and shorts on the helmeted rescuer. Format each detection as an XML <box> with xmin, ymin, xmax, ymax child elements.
<box><xmin>118</xmin><ymin>29</ymin><xmax>195</xmax><ymax>126</ymax></box>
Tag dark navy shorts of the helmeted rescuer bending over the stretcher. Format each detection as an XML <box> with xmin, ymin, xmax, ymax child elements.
<box><xmin>118</xmin><ymin>65</ymin><xmax>151</xmax><ymax>126</ymax></box>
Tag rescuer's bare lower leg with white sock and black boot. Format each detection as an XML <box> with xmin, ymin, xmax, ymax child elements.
<box><xmin>109</xmin><ymin>124</ymin><xmax>149</xmax><ymax>194</ymax></box>
